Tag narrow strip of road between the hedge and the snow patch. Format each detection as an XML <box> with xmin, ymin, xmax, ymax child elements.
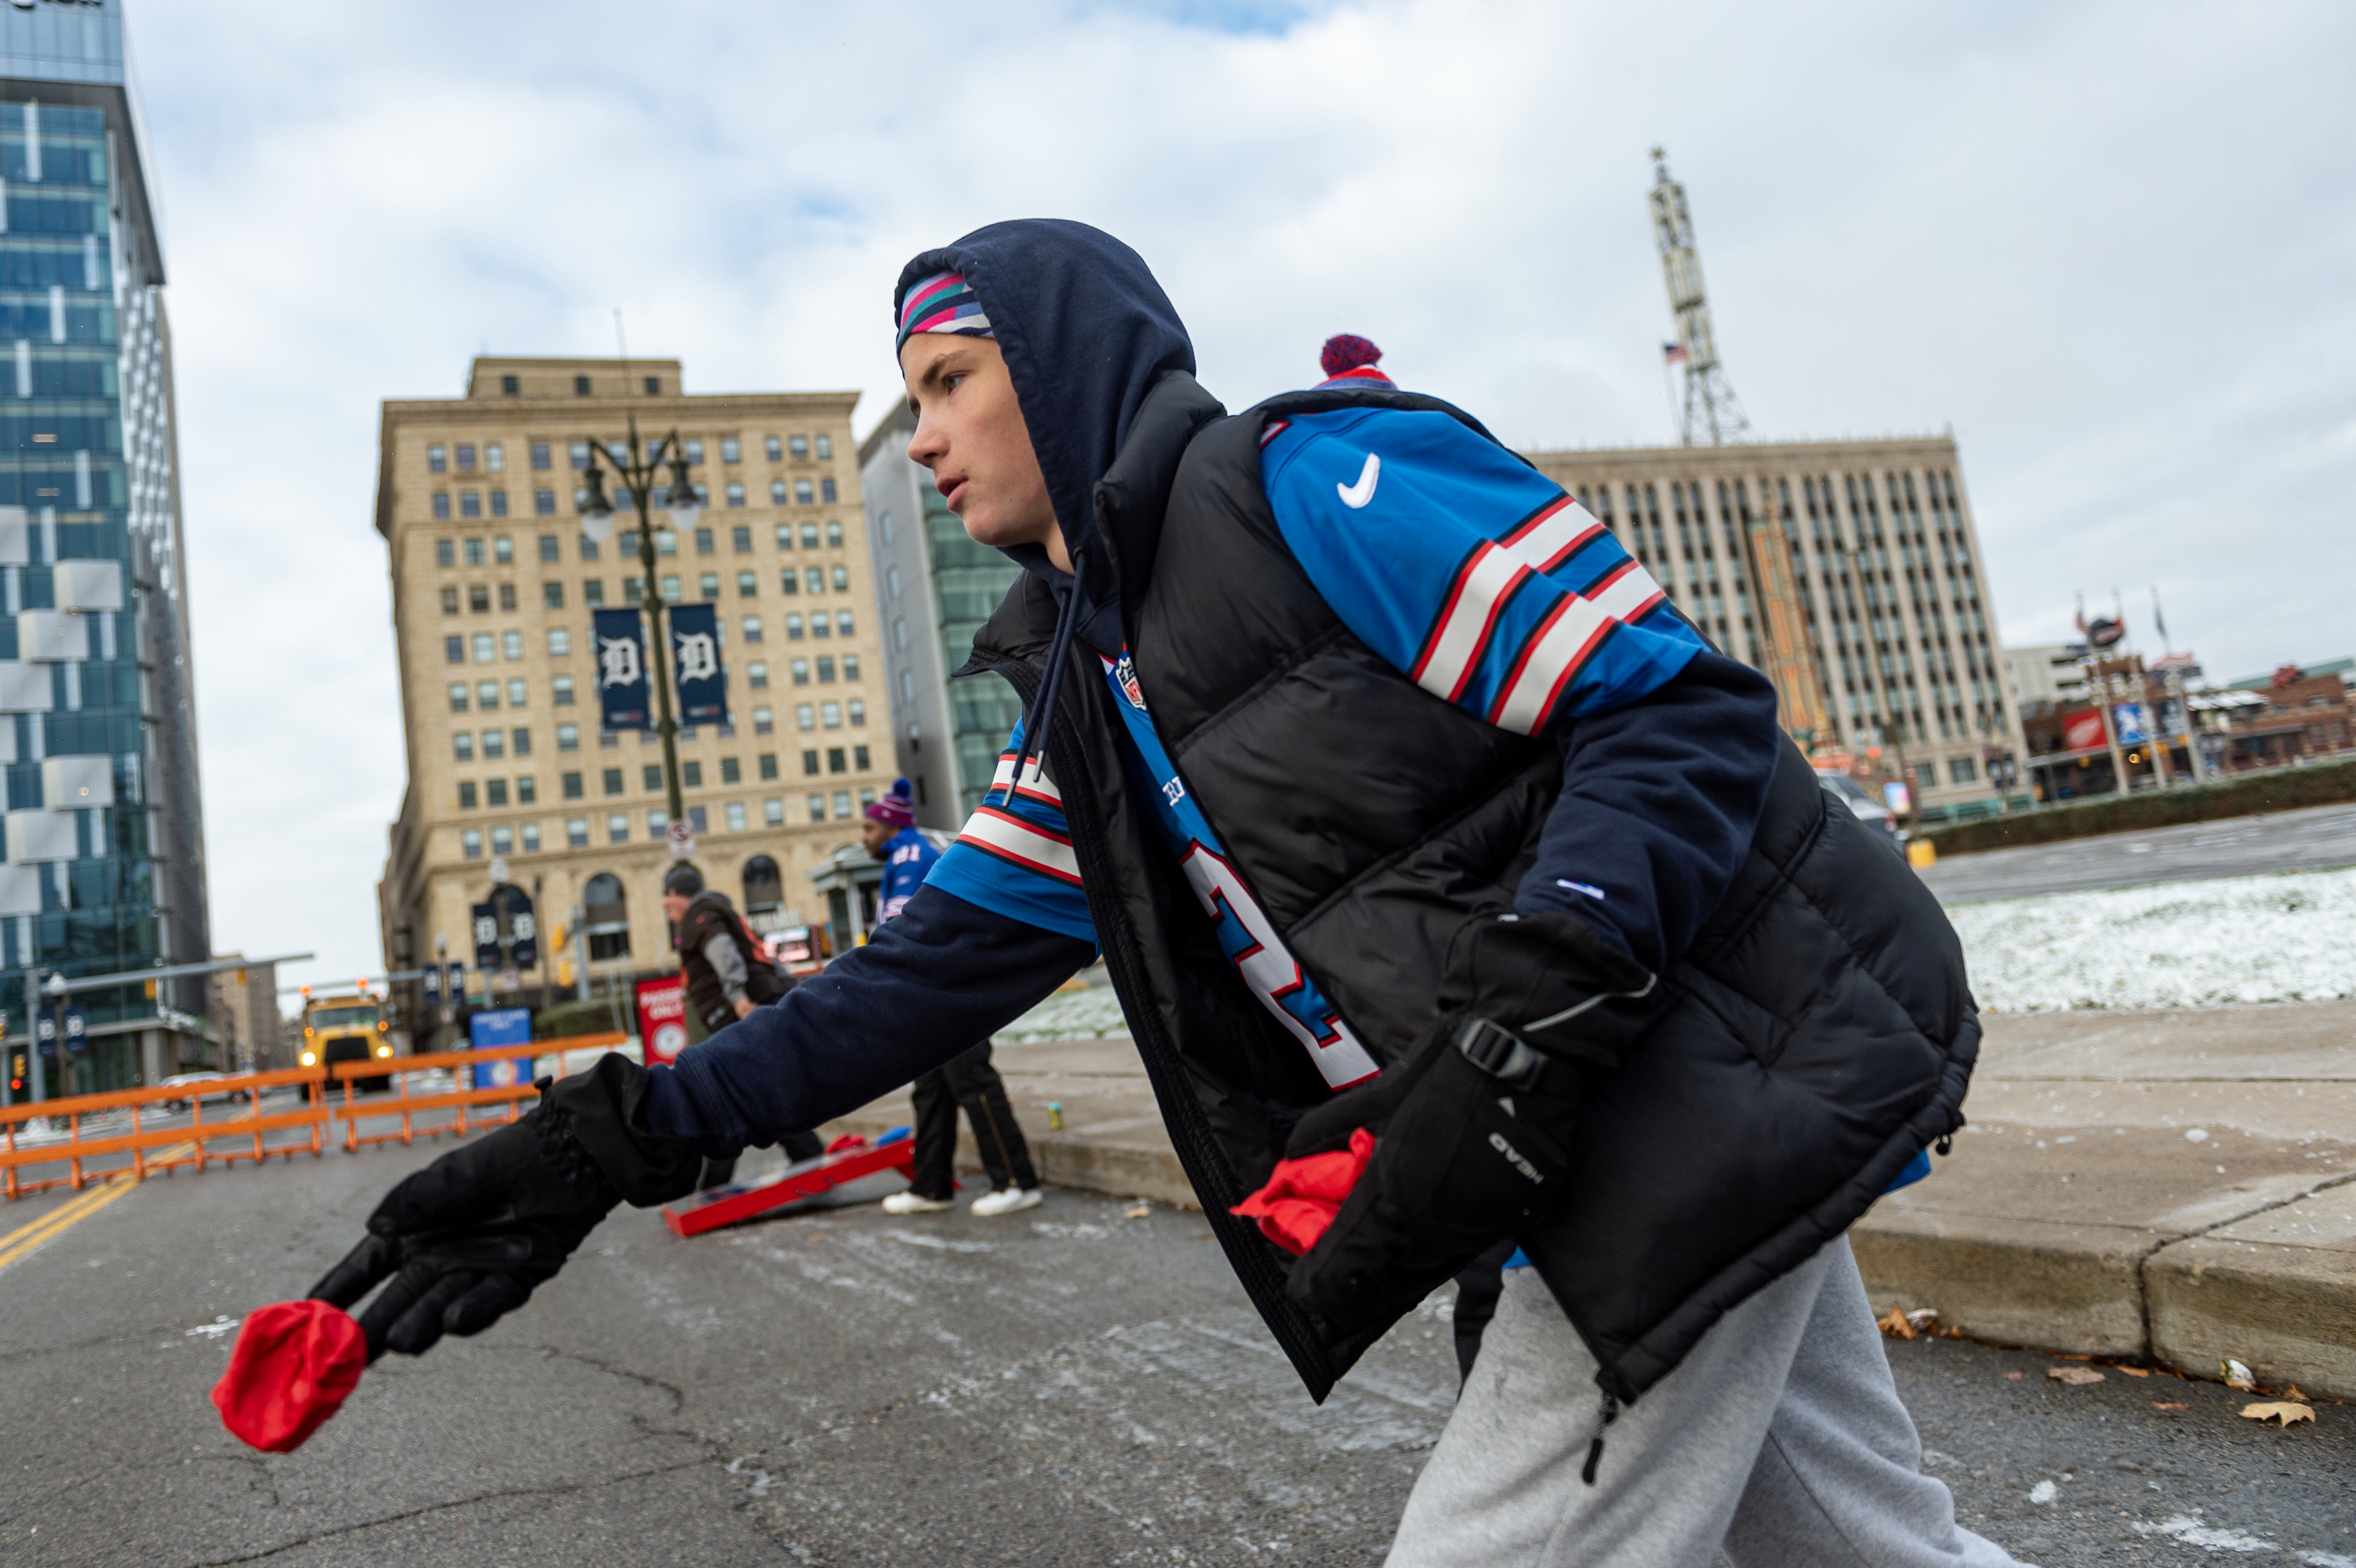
<box><xmin>1923</xmin><ymin>805</ymin><xmax>2356</xmax><ymax>904</ymax></box>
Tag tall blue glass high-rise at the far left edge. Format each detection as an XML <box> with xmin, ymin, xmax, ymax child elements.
<box><xmin>0</xmin><ymin>0</ymin><xmax>210</xmax><ymax>1100</ymax></box>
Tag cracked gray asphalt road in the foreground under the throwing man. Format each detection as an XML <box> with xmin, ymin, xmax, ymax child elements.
<box><xmin>0</xmin><ymin>1147</ymin><xmax>2356</xmax><ymax>1568</ymax></box>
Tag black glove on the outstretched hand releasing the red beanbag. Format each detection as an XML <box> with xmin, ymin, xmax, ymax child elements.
<box><xmin>311</xmin><ymin>1055</ymin><xmax>702</xmax><ymax>1361</ymax></box>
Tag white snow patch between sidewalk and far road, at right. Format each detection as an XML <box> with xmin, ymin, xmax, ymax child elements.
<box><xmin>1946</xmin><ymin>871</ymin><xmax>2356</xmax><ymax>1012</ymax></box>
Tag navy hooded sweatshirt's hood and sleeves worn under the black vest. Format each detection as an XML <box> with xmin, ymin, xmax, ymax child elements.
<box><xmin>643</xmin><ymin>219</ymin><xmax>1776</xmax><ymax>1156</ymax></box>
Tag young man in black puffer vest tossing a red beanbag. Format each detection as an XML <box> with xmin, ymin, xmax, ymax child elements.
<box><xmin>304</xmin><ymin>221</ymin><xmax>2010</xmax><ymax>1568</ymax></box>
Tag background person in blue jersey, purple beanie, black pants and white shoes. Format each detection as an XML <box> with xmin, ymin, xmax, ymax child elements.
<box><xmin>860</xmin><ymin>779</ymin><xmax>1039</xmax><ymax>1220</ymax></box>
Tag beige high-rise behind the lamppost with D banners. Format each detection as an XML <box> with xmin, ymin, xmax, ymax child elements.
<box><xmin>377</xmin><ymin>358</ymin><xmax>893</xmax><ymax>1021</ymax></box>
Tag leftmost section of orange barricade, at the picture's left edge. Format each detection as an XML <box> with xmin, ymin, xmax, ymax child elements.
<box><xmin>0</xmin><ymin>1067</ymin><xmax>327</xmax><ymax>1198</ymax></box>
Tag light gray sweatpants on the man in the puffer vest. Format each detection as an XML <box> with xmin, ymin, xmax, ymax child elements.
<box><xmin>1388</xmin><ymin>1236</ymin><xmax>2015</xmax><ymax>1568</ymax></box>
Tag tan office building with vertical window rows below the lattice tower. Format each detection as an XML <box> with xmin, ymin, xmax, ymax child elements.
<box><xmin>1527</xmin><ymin>435</ymin><xmax>2026</xmax><ymax>819</ymax></box>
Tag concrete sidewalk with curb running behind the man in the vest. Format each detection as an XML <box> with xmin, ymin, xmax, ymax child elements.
<box><xmin>829</xmin><ymin>1003</ymin><xmax>2356</xmax><ymax>1398</ymax></box>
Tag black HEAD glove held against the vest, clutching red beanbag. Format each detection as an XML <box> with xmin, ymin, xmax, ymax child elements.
<box><xmin>1284</xmin><ymin>913</ymin><xmax>1656</xmax><ymax>1323</ymax></box>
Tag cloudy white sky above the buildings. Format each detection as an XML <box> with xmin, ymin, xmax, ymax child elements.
<box><xmin>132</xmin><ymin>0</ymin><xmax>2356</xmax><ymax>975</ymax></box>
